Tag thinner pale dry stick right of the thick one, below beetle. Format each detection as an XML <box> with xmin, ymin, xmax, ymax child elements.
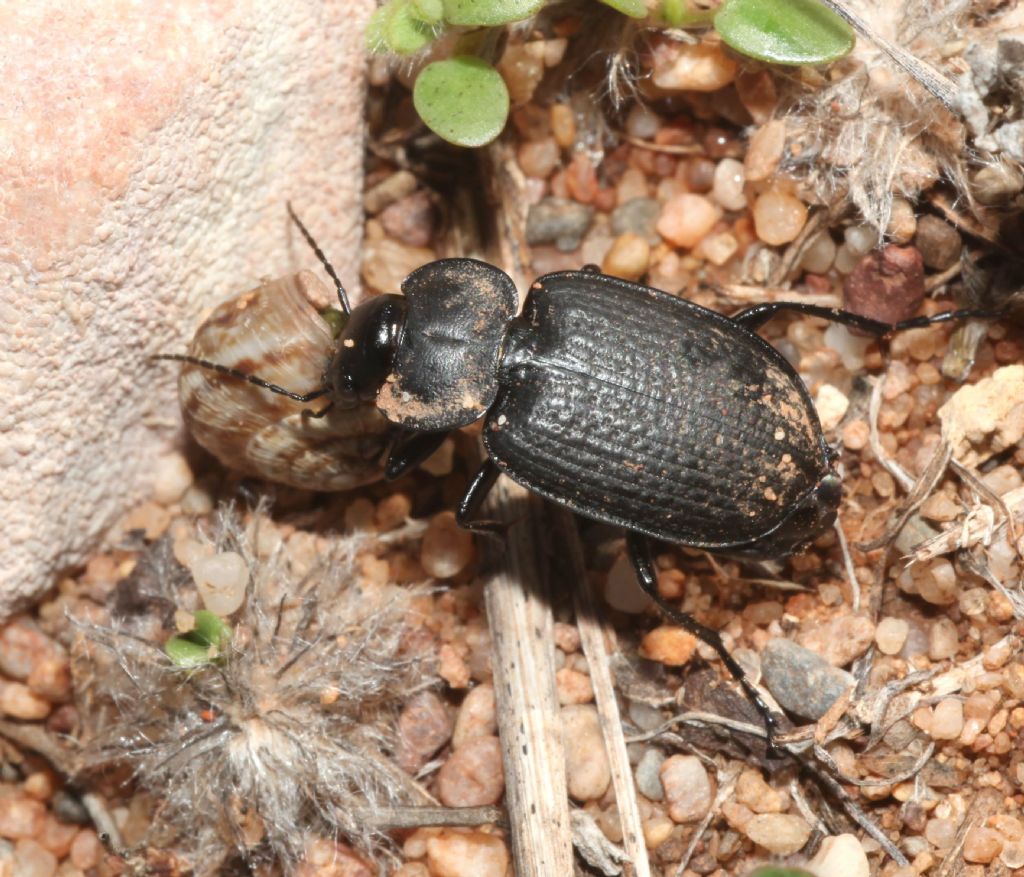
<box><xmin>550</xmin><ymin>508</ymin><xmax>650</xmax><ymax>877</ymax></box>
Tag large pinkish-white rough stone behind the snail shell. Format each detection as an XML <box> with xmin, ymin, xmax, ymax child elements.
<box><xmin>0</xmin><ymin>0</ymin><xmax>375</xmax><ymax>617</ymax></box>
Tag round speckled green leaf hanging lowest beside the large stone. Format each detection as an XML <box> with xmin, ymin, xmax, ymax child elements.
<box><xmin>413</xmin><ymin>55</ymin><xmax>509</xmax><ymax>147</ymax></box>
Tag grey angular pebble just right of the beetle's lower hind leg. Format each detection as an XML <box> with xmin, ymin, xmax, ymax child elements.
<box><xmin>761</xmin><ymin>637</ymin><xmax>854</xmax><ymax>721</ymax></box>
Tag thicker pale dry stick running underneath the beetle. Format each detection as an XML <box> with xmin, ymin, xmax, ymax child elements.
<box><xmin>482</xmin><ymin>141</ymin><xmax>573</xmax><ymax>877</ymax></box>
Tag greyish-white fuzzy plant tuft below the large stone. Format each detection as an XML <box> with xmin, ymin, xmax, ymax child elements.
<box><xmin>74</xmin><ymin>510</ymin><xmax>429</xmax><ymax>873</ymax></box>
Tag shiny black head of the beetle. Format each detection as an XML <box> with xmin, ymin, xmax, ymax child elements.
<box><xmin>327</xmin><ymin>295</ymin><xmax>406</xmax><ymax>408</ymax></box>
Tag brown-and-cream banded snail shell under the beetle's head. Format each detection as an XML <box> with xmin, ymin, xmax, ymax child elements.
<box><xmin>178</xmin><ymin>272</ymin><xmax>394</xmax><ymax>491</ymax></box>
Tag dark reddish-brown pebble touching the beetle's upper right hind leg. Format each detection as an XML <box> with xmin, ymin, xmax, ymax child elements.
<box><xmin>843</xmin><ymin>245</ymin><xmax>925</xmax><ymax>323</ymax></box>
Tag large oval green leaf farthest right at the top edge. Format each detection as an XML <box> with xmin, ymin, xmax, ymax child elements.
<box><xmin>715</xmin><ymin>0</ymin><xmax>854</xmax><ymax>65</ymax></box>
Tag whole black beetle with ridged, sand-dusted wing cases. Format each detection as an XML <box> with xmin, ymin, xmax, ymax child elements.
<box><xmin>169</xmin><ymin>214</ymin><xmax>993</xmax><ymax>738</ymax></box>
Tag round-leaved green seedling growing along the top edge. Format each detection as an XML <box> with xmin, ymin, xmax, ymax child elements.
<box><xmin>367</xmin><ymin>0</ymin><xmax>854</xmax><ymax>147</ymax></box>
